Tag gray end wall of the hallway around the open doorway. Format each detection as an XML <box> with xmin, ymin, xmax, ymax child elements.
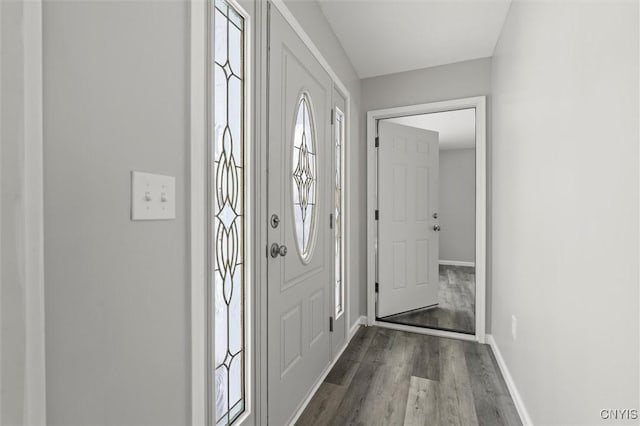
<box><xmin>358</xmin><ymin>58</ymin><xmax>491</xmax><ymax>330</ymax></box>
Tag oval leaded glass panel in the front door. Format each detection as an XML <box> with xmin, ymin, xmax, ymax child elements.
<box><xmin>291</xmin><ymin>94</ymin><xmax>318</xmax><ymax>262</ymax></box>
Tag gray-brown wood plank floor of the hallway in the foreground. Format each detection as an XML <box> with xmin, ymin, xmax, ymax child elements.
<box><xmin>296</xmin><ymin>327</ymin><xmax>521</xmax><ymax>426</ymax></box>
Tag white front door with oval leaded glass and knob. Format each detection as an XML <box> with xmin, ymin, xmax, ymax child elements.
<box><xmin>267</xmin><ymin>7</ymin><xmax>333</xmax><ymax>425</ymax></box>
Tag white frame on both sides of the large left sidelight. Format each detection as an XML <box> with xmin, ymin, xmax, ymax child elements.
<box><xmin>188</xmin><ymin>0</ymin><xmax>255</xmax><ymax>426</ymax></box>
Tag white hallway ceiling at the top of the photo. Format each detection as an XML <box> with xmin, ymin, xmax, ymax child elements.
<box><xmin>318</xmin><ymin>0</ymin><xmax>511</xmax><ymax>78</ymax></box>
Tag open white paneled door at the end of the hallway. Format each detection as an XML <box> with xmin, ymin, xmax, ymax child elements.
<box><xmin>377</xmin><ymin>121</ymin><xmax>439</xmax><ymax>317</ymax></box>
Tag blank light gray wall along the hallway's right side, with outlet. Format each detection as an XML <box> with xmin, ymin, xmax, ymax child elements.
<box><xmin>492</xmin><ymin>0</ymin><xmax>640</xmax><ymax>425</ymax></box>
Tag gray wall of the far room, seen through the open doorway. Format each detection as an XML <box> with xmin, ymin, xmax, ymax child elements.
<box><xmin>438</xmin><ymin>148</ymin><xmax>476</xmax><ymax>262</ymax></box>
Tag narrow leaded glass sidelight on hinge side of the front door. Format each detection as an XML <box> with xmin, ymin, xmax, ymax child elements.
<box><xmin>333</xmin><ymin>108</ymin><xmax>344</xmax><ymax>318</ymax></box>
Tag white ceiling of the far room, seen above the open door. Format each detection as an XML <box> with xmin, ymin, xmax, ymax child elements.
<box><xmin>389</xmin><ymin>108</ymin><xmax>476</xmax><ymax>150</ymax></box>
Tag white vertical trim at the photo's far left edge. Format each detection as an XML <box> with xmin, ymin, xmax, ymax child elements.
<box><xmin>0</xmin><ymin>0</ymin><xmax>47</xmax><ymax>425</ymax></box>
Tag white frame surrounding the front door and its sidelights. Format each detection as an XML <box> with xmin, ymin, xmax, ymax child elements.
<box><xmin>188</xmin><ymin>0</ymin><xmax>357</xmax><ymax>425</ymax></box>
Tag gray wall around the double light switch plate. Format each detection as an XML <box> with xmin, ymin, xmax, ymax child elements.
<box><xmin>43</xmin><ymin>1</ymin><xmax>190</xmax><ymax>425</ymax></box>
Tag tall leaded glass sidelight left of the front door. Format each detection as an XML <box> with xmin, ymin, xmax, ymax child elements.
<box><xmin>210</xmin><ymin>0</ymin><xmax>246</xmax><ymax>425</ymax></box>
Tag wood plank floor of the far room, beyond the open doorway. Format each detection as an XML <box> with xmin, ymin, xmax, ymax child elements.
<box><xmin>381</xmin><ymin>265</ymin><xmax>476</xmax><ymax>334</ymax></box>
